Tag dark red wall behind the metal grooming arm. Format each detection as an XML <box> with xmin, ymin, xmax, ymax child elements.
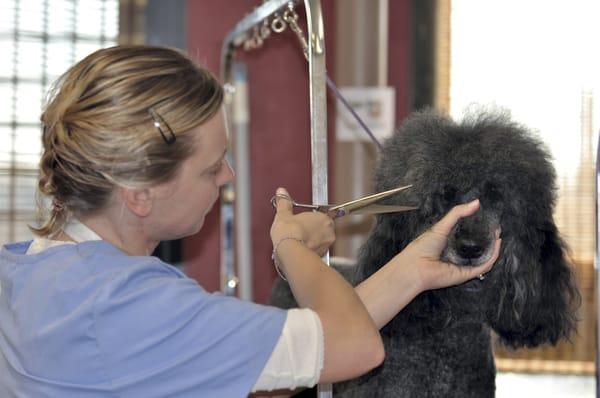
<box><xmin>184</xmin><ymin>0</ymin><xmax>409</xmax><ymax>303</ymax></box>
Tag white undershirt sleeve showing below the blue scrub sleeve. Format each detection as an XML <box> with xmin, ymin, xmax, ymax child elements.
<box><xmin>252</xmin><ymin>308</ymin><xmax>325</xmax><ymax>392</ymax></box>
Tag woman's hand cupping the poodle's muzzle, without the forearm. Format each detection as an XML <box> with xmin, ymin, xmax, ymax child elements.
<box><xmin>392</xmin><ymin>200</ymin><xmax>501</xmax><ymax>290</ymax></box>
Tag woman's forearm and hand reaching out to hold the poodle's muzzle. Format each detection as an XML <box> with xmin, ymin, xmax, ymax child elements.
<box><xmin>356</xmin><ymin>201</ymin><xmax>501</xmax><ymax>328</ymax></box>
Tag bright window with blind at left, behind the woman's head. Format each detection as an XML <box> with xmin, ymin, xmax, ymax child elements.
<box><xmin>0</xmin><ymin>0</ymin><xmax>119</xmax><ymax>243</ymax></box>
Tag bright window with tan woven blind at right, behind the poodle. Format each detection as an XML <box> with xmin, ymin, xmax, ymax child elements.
<box><xmin>444</xmin><ymin>0</ymin><xmax>600</xmax><ymax>375</ymax></box>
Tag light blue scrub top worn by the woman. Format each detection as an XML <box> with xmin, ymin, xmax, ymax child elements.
<box><xmin>0</xmin><ymin>241</ymin><xmax>286</xmax><ymax>398</ymax></box>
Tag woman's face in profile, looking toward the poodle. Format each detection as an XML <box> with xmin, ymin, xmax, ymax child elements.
<box><xmin>150</xmin><ymin>110</ymin><xmax>233</xmax><ymax>240</ymax></box>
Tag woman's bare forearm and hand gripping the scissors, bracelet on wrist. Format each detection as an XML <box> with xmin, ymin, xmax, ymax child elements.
<box><xmin>271</xmin><ymin>190</ymin><xmax>384</xmax><ymax>383</ymax></box>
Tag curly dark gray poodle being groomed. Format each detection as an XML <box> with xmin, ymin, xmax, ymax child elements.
<box><xmin>272</xmin><ymin>110</ymin><xmax>580</xmax><ymax>398</ymax></box>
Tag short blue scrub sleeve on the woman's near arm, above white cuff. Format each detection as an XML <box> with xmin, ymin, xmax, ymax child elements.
<box><xmin>94</xmin><ymin>264</ymin><xmax>286</xmax><ymax>397</ymax></box>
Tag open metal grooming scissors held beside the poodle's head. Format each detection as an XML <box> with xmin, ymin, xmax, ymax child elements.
<box><xmin>271</xmin><ymin>185</ymin><xmax>418</xmax><ymax>219</ymax></box>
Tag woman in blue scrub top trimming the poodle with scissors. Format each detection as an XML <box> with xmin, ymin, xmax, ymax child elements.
<box><xmin>0</xmin><ymin>46</ymin><xmax>500</xmax><ymax>397</ymax></box>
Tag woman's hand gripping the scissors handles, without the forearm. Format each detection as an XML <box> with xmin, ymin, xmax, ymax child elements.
<box><xmin>271</xmin><ymin>188</ymin><xmax>335</xmax><ymax>256</ymax></box>
